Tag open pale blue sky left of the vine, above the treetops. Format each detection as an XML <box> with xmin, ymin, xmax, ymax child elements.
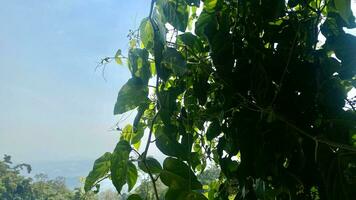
<box><xmin>0</xmin><ymin>0</ymin><xmax>150</xmax><ymax>162</ymax></box>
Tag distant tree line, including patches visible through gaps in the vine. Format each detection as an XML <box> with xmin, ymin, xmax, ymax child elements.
<box><xmin>0</xmin><ymin>155</ymin><xmax>220</xmax><ymax>200</ymax></box>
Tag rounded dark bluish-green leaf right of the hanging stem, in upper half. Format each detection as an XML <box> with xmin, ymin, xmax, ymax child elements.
<box><xmin>162</xmin><ymin>48</ymin><xmax>187</xmax><ymax>76</ymax></box>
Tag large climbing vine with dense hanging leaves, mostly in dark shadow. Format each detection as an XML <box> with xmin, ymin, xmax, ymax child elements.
<box><xmin>85</xmin><ymin>0</ymin><xmax>356</xmax><ymax>200</ymax></box>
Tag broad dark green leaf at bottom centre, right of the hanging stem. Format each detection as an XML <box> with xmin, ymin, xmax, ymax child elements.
<box><xmin>160</xmin><ymin>157</ymin><xmax>202</xmax><ymax>191</ymax></box>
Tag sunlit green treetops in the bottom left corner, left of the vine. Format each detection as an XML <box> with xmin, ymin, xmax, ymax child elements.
<box><xmin>0</xmin><ymin>155</ymin><xmax>97</xmax><ymax>200</ymax></box>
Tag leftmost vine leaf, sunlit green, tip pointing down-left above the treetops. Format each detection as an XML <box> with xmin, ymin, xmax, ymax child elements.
<box><xmin>84</xmin><ymin>152</ymin><xmax>111</xmax><ymax>192</ymax></box>
